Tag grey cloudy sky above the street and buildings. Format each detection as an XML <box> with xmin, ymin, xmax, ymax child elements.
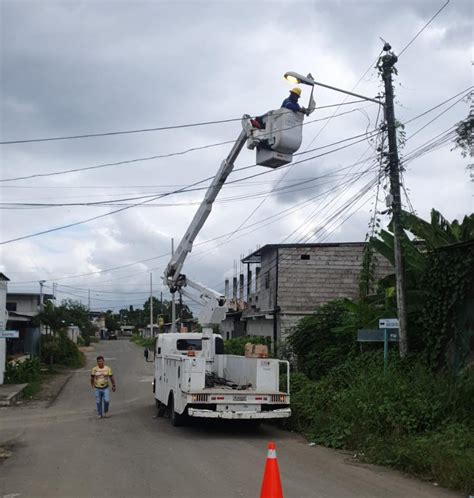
<box><xmin>0</xmin><ymin>0</ymin><xmax>474</xmax><ymax>310</ymax></box>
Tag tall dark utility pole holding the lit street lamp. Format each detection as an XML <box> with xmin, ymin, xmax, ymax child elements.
<box><xmin>382</xmin><ymin>43</ymin><xmax>408</xmax><ymax>358</ymax></box>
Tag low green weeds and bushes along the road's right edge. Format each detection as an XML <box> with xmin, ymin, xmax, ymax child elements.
<box><xmin>285</xmin><ymin>352</ymin><xmax>474</xmax><ymax>489</ymax></box>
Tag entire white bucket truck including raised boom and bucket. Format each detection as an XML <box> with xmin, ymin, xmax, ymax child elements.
<box><xmin>153</xmin><ymin>96</ymin><xmax>314</xmax><ymax>426</ymax></box>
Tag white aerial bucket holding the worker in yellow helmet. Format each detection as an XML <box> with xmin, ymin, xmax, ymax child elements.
<box><xmin>242</xmin><ymin>109</ymin><xmax>304</xmax><ymax>168</ymax></box>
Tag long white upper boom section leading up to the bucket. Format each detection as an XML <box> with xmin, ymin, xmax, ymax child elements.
<box><xmin>164</xmin><ymin>130</ymin><xmax>247</xmax><ymax>292</ymax></box>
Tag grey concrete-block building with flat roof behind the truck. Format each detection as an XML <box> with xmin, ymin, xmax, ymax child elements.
<box><xmin>241</xmin><ymin>242</ymin><xmax>393</xmax><ymax>341</ymax></box>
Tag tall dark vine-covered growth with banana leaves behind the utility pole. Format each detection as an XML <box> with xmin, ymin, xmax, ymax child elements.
<box><xmin>371</xmin><ymin>209</ymin><xmax>474</xmax><ymax>366</ymax></box>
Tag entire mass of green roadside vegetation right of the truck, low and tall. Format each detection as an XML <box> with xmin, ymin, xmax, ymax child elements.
<box><xmin>284</xmin><ymin>211</ymin><xmax>474</xmax><ymax>493</ymax></box>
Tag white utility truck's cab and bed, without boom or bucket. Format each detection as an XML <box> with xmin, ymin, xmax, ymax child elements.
<box><xmin>154</xmin><ymin>329</ymin><xmax>291</xmax><ymax>426</ymax></box>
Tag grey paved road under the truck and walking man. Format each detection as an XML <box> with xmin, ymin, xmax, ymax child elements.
<box><xmin>0</xmin><ymin>340</ymin><xmax>459</xmax><ymax>498</ymax></box>
